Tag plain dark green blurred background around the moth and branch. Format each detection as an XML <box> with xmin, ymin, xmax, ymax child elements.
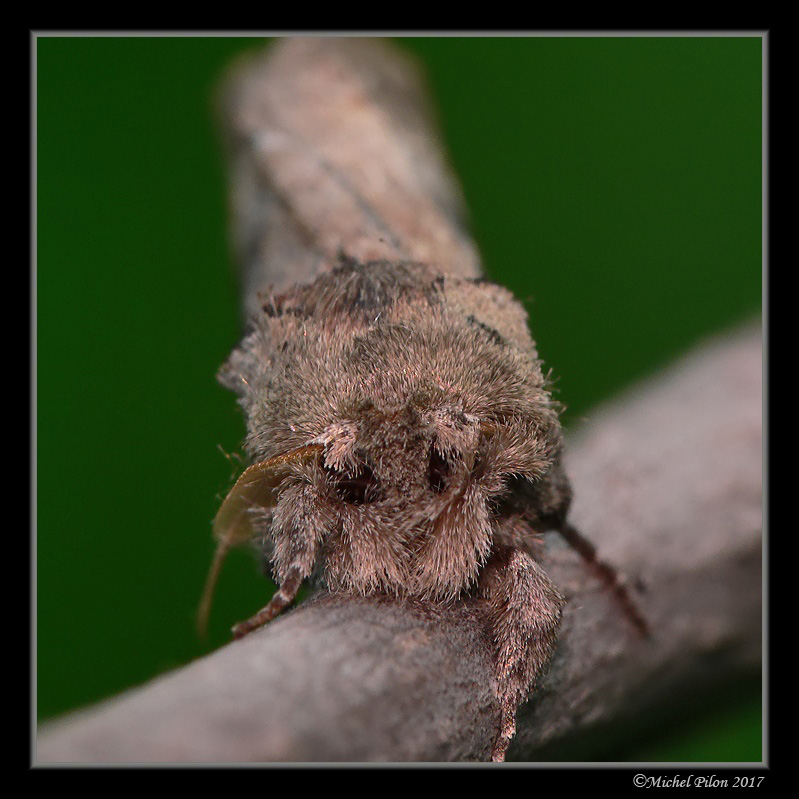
<box><xmin>34</xmin><ymin>36</ymin><xmax>762</xmax><ymax>761</ymax></box>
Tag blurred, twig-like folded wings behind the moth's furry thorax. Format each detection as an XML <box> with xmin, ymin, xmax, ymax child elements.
<box><xmin>220</xmin><ymin>37</ymin><xmax>482</xmax><ymax>312</ymax></box>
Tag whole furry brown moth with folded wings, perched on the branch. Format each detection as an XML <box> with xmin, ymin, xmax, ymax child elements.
<box><xmin>200</xmin><ymin>40</ymin><xmax>641</xmax><ymax>760</ymax></box>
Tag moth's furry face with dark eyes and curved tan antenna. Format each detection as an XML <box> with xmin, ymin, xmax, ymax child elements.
<box><xmin>198</xmin><ymin>398</ymin><xmax>559</xmax><ymax>631</ymax></box>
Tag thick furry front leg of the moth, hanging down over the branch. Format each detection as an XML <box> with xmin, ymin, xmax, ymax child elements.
<box><xmin>478</xmin><ymin>548</ymin><xmax>565</xmax><ymax>762</ymax></box>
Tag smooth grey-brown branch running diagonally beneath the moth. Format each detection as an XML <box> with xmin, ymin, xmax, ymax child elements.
<box><xmin>37</xmin><ymin>320</ymin><xmax>762</xmax><ymax>763</ymax></box>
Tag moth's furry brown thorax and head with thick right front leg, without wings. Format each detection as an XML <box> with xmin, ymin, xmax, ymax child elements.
<box><xmin>220</xmin><ymin>259</ymin><xmax>570</xmax><ymax>751</ymax></box>
